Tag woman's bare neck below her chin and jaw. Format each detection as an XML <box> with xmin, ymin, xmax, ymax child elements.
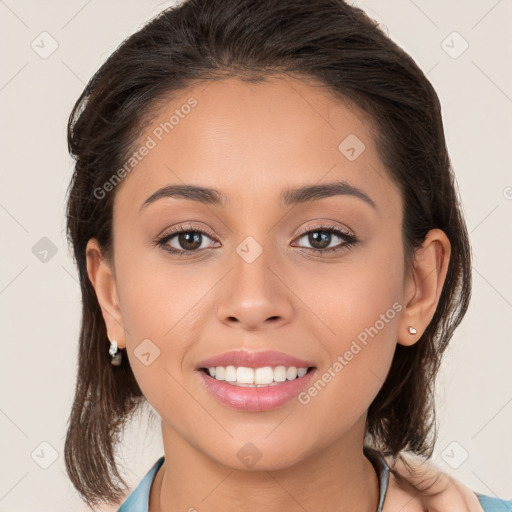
<box><xmin>149</xmin><ymin>418</ymin><xmax>379</xmax><ymax>512</ymax></box>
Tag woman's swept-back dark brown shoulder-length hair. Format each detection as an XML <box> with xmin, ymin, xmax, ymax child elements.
<box><xmin>64</xmin><ymin>0</ymin><xmax>471</xmax><ymax>506</ymax></box>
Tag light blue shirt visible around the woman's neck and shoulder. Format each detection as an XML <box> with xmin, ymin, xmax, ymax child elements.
<box><xmin>117</xmin><ymin>448</ymin><xmax>512</xmax><ymax>512</ymax></box>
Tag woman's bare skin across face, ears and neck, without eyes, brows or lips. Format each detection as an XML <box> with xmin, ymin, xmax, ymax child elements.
<box><xmin>87</xmin><ymin>76</ymin><xmax>478</xmax><ymax>512</ymax></box>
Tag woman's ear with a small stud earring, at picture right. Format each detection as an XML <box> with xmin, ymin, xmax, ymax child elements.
<box><xmin>397</xmin><ymin>229</ymin><xmax>451</xmax><ymax>346</ymax></box>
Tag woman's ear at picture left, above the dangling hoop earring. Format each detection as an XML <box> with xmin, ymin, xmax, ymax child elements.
<box><xmin>85</xmin><ymin>238</ymin><xmax>126</xmax><ymax>348</ymax></box>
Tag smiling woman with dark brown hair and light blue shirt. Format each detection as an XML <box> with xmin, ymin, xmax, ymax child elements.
<box><xmin>65</xmin><ymin>0</ymin><xmax>511</xmax><ymax>512</ymax></box>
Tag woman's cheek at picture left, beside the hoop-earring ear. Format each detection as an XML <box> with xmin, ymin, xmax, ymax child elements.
<box><xmin>116</xmin><ymin>248</ymin><xmax>219</xmax><ymax>413</ymax></box>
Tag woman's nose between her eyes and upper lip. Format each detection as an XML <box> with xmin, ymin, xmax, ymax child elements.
<box><xmin>217</xmin><ymin>244</ymin><xmax>294</xmax><ymax>331</ymax></box>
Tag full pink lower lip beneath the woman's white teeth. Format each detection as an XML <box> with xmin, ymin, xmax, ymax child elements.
<box><xmin>198</xmin><ymin>368</ymin><xmax>316</xmax><ymax>412</ymax></box>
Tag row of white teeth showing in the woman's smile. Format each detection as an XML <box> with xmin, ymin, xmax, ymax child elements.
<box><xmin>208</xmin><ymin>365</ymin><xmax>308</xmax><ymax>387</ymax></box>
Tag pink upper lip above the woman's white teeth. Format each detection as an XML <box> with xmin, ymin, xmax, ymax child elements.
<box><xmin>198</xmin><ymin>350</ymin><xmax>315</xmax><ymax>368</ymax></box>
